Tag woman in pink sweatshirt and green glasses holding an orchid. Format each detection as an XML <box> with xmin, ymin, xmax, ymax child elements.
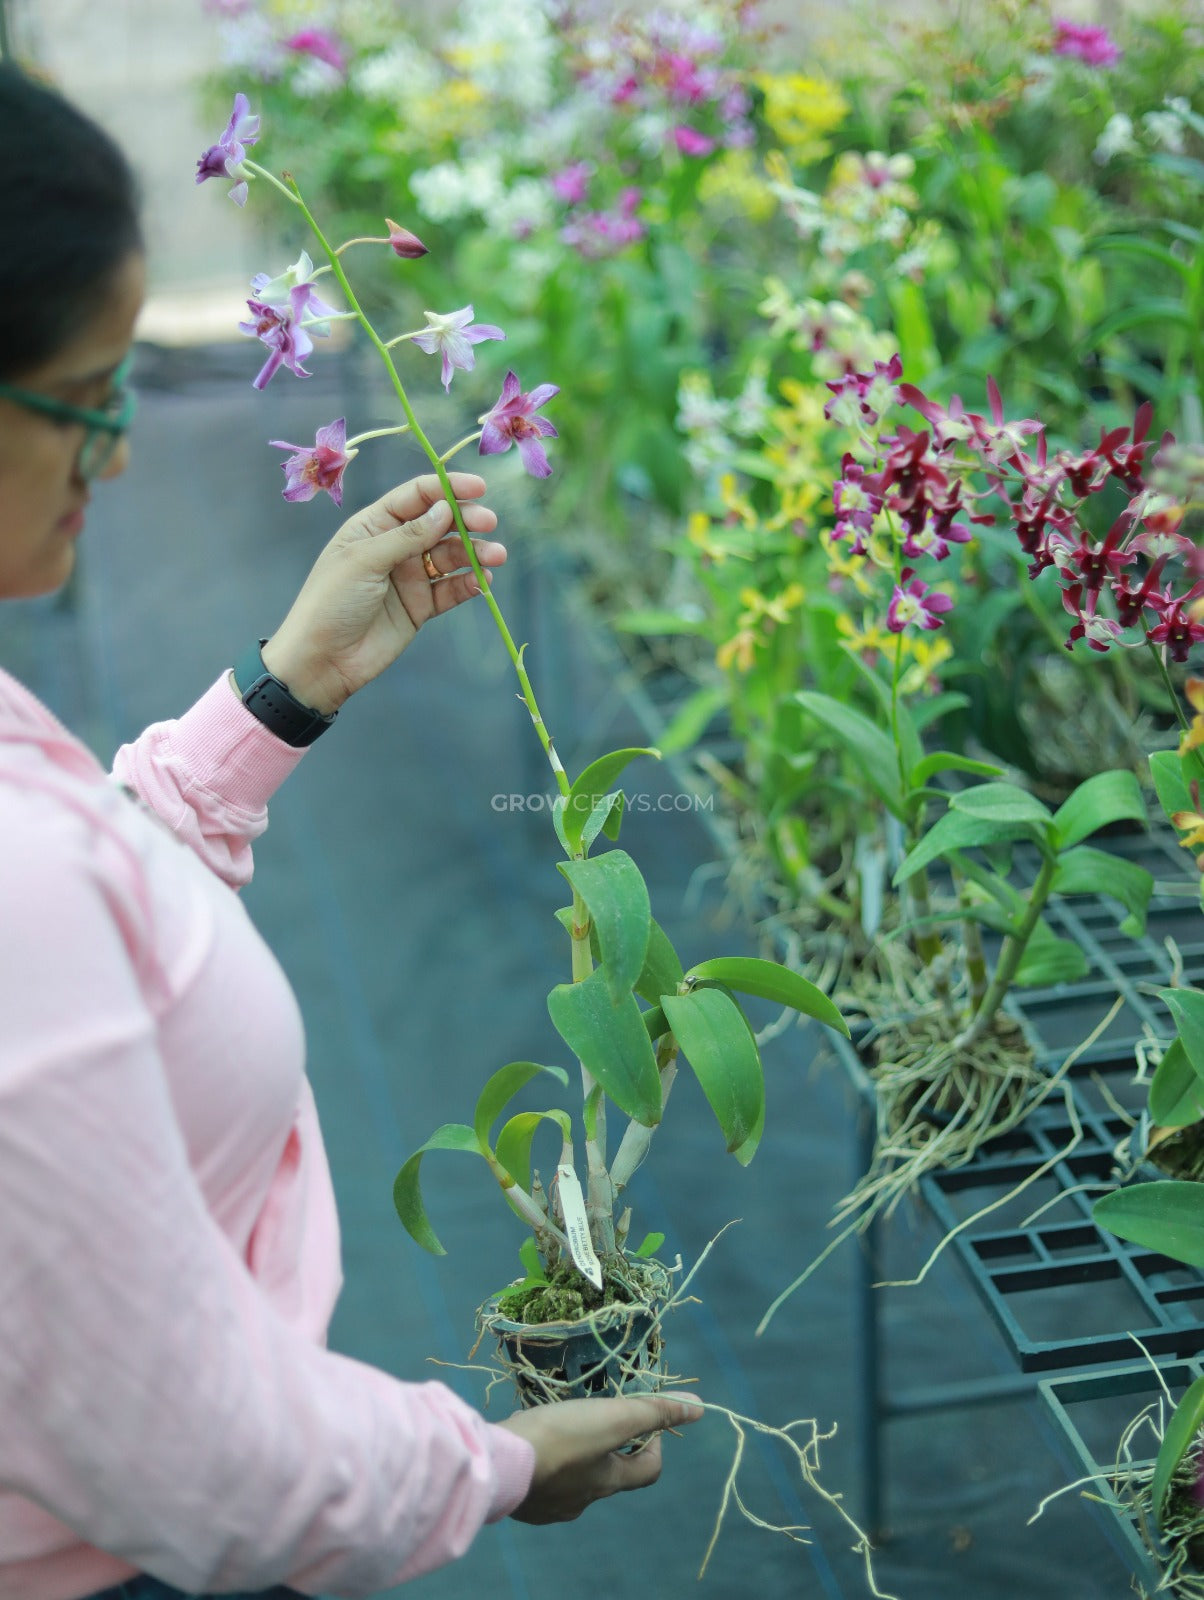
<box><xmin>0</xmin><ymin>66</ymin><xmax>701</xmax><ymax>1600</ymax></box>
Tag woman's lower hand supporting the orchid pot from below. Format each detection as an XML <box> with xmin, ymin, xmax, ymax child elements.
<box><xmin>500</xmin><ymin>1395</ymin><xmax>704</xmax><ymax>1522</ymax></box>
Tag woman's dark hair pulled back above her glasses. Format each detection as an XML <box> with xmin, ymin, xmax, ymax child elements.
<box><xmin>0</xmin><ymin>61</ymin><xmax>142</xmax><ymax>379</ymax></box>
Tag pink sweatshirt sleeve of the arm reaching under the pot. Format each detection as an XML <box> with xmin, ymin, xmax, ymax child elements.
<box><xmin>0</xmin><ymin>821</ymin><xmax>533</xmax><ymax>1597</ymax></box>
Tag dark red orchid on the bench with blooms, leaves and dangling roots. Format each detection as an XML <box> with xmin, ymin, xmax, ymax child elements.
<box><xmin>762</xmin><ymin>355</ymin><xmax>1178</xmax><ymax>1326</ymax></box>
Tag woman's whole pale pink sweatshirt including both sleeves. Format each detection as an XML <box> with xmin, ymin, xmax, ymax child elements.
<box><xmin>0</xmin><ymin>672</ymin><xmax>533</xmax><ymax>1600</ymax></box>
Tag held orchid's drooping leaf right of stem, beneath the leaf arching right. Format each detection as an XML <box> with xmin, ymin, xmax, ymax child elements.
<box><xmin>661</xmin><ymin>989</ymin><xmax>765</xmax><ymax>1166</ymax></box>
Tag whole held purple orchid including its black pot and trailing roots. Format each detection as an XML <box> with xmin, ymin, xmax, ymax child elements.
<box><xmin>197</xmin><ymin>94</ymin><xmax>903</xmax><ymax>1594</ymax></box>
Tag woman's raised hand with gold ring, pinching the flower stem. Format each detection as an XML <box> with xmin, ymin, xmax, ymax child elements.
<box><xmin>263</xmin><ymin>472</ymin><xmax>506</xmax><ymax>712</ymax></box>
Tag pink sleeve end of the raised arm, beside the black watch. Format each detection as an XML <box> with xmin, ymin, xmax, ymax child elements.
<box><xmin>114</xmin><ymin>672</ymin><xmax>306</xmax><ymax>888</ymax></box>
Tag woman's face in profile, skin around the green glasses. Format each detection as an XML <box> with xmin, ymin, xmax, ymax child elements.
<box><xmin>0</xmin><ymin>253</ymin><xmax>146</xmax><ymax>600</ymax></box>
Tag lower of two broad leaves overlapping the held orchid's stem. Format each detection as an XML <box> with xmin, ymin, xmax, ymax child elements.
<box><xmin>548</xmin><ymin>968</ymin><xmax>661</xmax><ymax>1128</ymax></box>
